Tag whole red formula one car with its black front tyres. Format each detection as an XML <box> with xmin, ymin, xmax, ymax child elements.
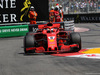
<box><xmin>24</xmin><ymin>23</ymin><xmax>81</xmax><ymax>53</ymax></box>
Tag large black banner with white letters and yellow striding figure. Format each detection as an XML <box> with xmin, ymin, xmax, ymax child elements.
<box><xmin>0</xmin><ymin>0</ymin><xmax>49</xmax><ymax>23</ymax></box>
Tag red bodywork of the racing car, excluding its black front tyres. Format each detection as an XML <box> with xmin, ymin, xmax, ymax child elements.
<box><xmin>26</xmin><ymin>23</ymin><xmax>79</xmax><ymax>53</ymax></box>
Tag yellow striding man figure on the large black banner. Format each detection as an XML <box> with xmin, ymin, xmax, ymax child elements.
<box><xmin>20</xmin><ymin>0</ymin><xmax>31</xmax><ymax>21</ymax></box>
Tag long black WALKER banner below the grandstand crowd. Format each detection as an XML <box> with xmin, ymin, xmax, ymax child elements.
<box><xmin>64</xmin><ymin>13</ymin><xmax>100</xmax><ymax>23</ymax></box>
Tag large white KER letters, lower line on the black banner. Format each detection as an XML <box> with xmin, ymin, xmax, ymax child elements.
<box><xmin>0</xmin><ymin>14</ymin><xmax>17</xmax><ymax>23</ymax></box>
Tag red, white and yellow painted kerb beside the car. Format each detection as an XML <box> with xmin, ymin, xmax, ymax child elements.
<box><xmin>52</xmin><ymin>48</ymin><xmax>100</xmax><ymax>59</ymax></box>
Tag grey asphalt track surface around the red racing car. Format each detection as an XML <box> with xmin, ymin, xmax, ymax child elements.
<box><xmin>0</xmin><ymin>23</ymin><xmax>100</xmax><ymax>75</ymax></box>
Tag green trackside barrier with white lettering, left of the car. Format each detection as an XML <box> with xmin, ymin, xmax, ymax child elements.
<box><xmin>0</xmin><ymin>25</ymin><xmax>29</xmax><ymax>37</ymax></box>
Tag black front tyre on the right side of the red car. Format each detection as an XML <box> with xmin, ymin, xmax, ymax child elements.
<box><xmin>70</xmin><ymin>32</ymin><xmax>81</xmax><ymax>52</ymax></box>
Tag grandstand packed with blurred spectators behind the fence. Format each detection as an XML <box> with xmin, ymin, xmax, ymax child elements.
<box><xmin>49</xmin><ymin>0</ymin><xmax>100</xmax><ymax>14</ymax></box>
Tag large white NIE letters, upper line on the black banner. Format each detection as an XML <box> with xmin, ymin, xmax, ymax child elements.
<box><xmin>0</xmin><ymin>0</ymin><xmax>16</xmax><ymax>9</ymax></box>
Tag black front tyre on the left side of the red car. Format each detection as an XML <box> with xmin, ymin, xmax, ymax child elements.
<box><xmin>24</xmin><ymin>35</ymin><xmax>35</xmax><ymax>54</ymax></box>
